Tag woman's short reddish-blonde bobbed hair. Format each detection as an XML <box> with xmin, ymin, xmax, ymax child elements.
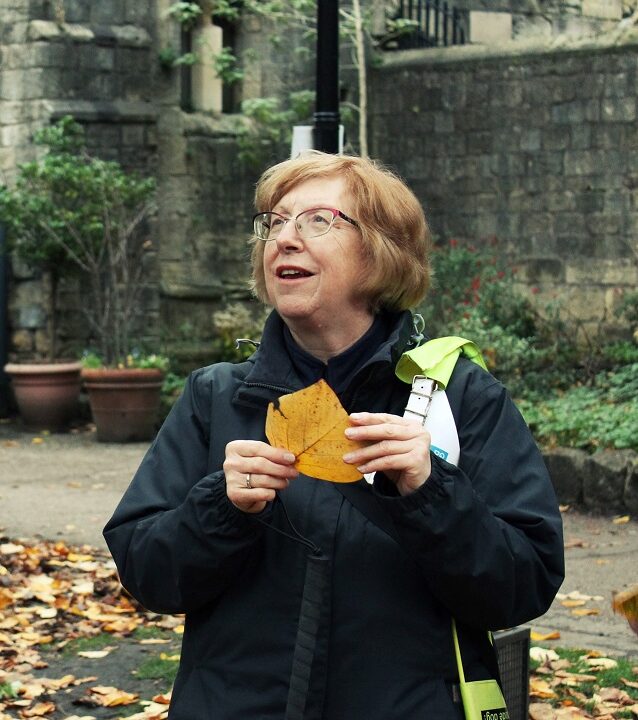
<box><xmin>251</xmin><ymin>150</ymin><xmax>432</xmax><ymax>311</ymax></box>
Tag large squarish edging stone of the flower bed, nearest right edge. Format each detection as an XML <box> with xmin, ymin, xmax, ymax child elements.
<box><xmin>583</xmin><ymin>450</ymin><xmax>636</xmax><ymax>513</ymax></box>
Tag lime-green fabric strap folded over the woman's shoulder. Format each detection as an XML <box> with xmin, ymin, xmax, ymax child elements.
<box><xmin>395</xmin><ymin>335</ymin><xmax>487</xmax><ymax>390</ymax></box>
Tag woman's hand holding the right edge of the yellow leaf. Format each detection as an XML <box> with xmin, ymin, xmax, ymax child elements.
<box><xmin>343</xmin><ymin>412</ymin><xmax>432</xmax><ymax>495</ymax></box>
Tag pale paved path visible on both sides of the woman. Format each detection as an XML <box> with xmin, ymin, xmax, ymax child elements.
<box><xmin>0</xmin><ymin>421</ymin><xmax>638</xmax><ymax>658</ymax></box>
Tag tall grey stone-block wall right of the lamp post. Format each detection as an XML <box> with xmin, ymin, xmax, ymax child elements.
<box><xmin>370</xmin><ymin>33</ymin><xmax>638</xmax><ymax>338</ymax></box>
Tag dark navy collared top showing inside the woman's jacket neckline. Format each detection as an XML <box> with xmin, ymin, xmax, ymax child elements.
<box><xmin>283</xmin><ymin>312</ymin><xmax>397</xmax><ymax>395</ymax></box>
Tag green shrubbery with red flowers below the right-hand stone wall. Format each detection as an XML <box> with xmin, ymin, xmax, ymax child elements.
<box><xmin>419</xmin><ymin>240</ymin><xmax>638</xmax><ymax>452</ymax></box>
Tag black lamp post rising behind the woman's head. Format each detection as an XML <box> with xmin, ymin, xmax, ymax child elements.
<box><xmin>313</xmin><ymin>0</ymin><xmax>339</xmax><ymax>153</ymax></box>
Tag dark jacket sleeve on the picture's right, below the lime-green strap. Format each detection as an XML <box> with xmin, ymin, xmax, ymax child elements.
<box><xmin>375</xmin><ymin>366</ymin><xmax>564</xmax><ymax>630</ymax></box>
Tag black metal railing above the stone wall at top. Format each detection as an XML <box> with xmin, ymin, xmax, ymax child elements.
<box><xmin>383</xmin><ymin>0</ymin><xmax>467</xmax><ymax>50</ymax></box>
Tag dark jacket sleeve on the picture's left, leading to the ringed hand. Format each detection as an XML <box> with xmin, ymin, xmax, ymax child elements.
<box><xmin>104</xmin><ymin>371</ymin><xmax>267</xmax><ymax>613</ymax></box>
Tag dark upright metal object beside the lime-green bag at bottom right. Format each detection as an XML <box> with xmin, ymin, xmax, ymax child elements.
<box><xmin>494</xmin><ymin>627</ymin><xmax>530</xmax><ymax>720</ymax></box>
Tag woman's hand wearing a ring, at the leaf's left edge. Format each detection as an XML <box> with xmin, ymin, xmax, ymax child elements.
<box><xmin>224</xmin><ymin>440</ymin><xmax>298</xmax><ymax>513</ymax></box>
